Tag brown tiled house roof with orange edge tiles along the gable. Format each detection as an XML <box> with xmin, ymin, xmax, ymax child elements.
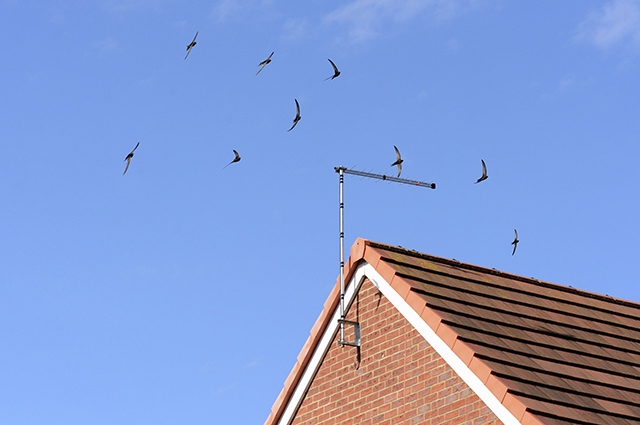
<box><xmin>266</xmin><ymin>239</ymin><xmax>640</xmax><ymax>425</ymax></box>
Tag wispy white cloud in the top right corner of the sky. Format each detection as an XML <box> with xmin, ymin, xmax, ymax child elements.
<box><xmin>576</xmin><ymin>0</ymin><xmax>640</xmax><ymax>49</ymax></box>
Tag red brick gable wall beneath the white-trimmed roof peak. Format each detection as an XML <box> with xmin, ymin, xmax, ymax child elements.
<box><xmin>293</xmin><ymin>281</ymin><xmax>502</xmax><ymax>425</ymax></box>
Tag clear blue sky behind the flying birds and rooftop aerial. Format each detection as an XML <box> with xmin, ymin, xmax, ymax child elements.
<box><xmin>0</xmin><ymin>0</ymin><xmax>640</xmax><ymax>425</ymax></box>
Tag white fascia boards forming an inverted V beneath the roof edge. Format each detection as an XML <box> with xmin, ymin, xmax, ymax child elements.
<box><xmin>278</xmin><ymin>262</ymin><xmax>522</xmax><ymax>425</ymax></box>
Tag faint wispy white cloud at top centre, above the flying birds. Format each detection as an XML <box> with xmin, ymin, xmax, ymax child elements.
<box><xmin>324</xmin><ymin>0</ymin><xmax>475</xmax><ymax>42</ymax></box>
